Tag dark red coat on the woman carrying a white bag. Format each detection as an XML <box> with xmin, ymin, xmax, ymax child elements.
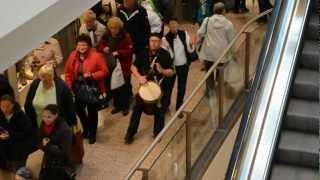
<box><xmin>97</xmin><ymin>33</ymin><xmax>133</xmax><ymax>79</ymax></box>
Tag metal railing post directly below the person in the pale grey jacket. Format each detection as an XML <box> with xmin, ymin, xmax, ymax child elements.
<box><xmin>217</xmin><ymin>66</ymin><xmax>225</xmax><ymax>128</ymax></box>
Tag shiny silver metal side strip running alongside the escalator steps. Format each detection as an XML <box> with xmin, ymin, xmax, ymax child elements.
<box><xmin>225</xmin><ymin>0</ymin><xmax>310</xmax><ymax>180</ymax></box>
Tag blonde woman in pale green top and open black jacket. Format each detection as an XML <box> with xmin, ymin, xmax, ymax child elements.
<box><xmin>24</xmin><ymin>65</ymin><xmax>76</xmax><ymax>128</ymax></box>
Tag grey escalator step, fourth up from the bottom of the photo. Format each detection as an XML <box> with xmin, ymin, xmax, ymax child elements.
<box><xmin>293</xmin><ymin>69</ymin><xmax>320</xmax><ymax>101</ymax></box>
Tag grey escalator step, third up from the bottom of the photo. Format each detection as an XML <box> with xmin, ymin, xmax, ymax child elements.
<box><xmin>283</xmin><ymin>98</ymin><xmax>320</xmax><ymax>134</ymax></box>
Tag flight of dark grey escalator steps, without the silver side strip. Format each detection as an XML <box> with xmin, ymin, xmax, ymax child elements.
<box><xmin>270</xmin><ymin>1</ymin><xmax>320</xmax><ymax>180</ymax></box>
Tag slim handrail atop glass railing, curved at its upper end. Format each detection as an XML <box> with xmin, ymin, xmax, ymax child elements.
<box><xmin>125</xmin><ymin>9</ymin><xmax>272</xmax><ymax>180</ymax></box>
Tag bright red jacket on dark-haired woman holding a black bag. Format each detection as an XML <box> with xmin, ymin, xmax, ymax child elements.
<box><xmin>65</xmin><ymin>49</ymin><xmax>109</xmax><ymax>93</ymax></box>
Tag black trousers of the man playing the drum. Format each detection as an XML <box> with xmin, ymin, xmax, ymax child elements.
<box><xmin>127</xmin><ymin>77</ymin><xmax>174</xmax><ymax>137</ymax></box>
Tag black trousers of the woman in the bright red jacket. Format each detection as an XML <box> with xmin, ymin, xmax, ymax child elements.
<box><xmin>75</xmin><ymin>100</ymin><xmax>98</xmax><ymax>138</ymax></box>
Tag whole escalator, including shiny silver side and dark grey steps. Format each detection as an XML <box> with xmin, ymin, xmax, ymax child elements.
<box><xmin>225</xmin><ymin>0</ymin><xmax>320</xmax><ymax>180</ymax></box>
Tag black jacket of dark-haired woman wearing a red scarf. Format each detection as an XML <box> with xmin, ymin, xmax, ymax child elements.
<box><xmin>39</xmin><ymin>117</ymin><xmax>72</xmax><ymax>171</ymax></box>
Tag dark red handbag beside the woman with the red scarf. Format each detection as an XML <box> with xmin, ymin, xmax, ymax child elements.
<box><xmin>71</xmin><ymin>125</ymin><xmax>84</xmax><ymax>164</ymax></box>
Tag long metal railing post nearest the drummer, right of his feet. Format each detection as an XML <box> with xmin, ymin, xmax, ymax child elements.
<box><xmin>185</xmin><ymin>112</ymin><xmax>191</xmax><ymax>180</ymax></box>
